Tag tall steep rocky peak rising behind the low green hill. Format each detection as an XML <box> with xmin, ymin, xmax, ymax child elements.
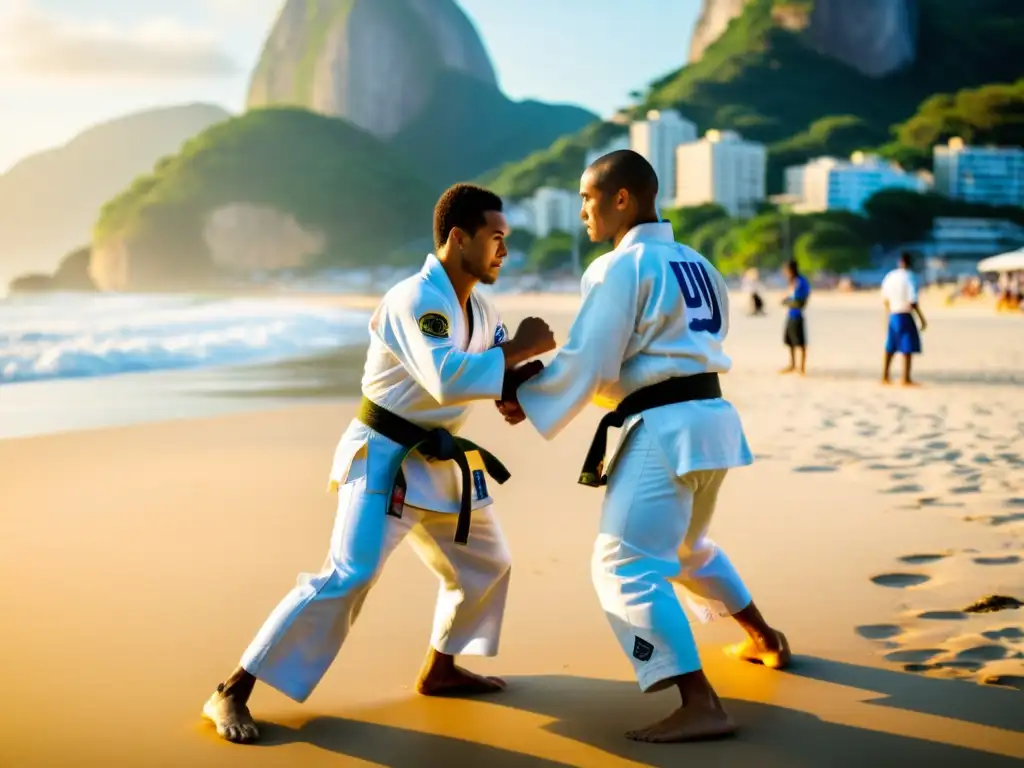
<box><xmin>249</xmin><ymin>0</ymin><xmax>596</xmax><ymax>187</ymax></box>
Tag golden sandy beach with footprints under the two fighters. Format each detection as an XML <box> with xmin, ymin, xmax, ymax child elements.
<box><xmin>0</xmin><ymin>295</ymin><xmax>1024</xmax><ymax>768</ymax></box>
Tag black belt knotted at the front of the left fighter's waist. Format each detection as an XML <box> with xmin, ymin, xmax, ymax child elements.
<box><xmin>355</xmin><ymin>397</ymin><xmax>512</xmax><ymax>544</ymax></box>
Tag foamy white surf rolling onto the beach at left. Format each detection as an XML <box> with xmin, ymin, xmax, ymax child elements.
<box><xmin>0</xmin><ymin>295</ymin><xmax>368</xmax><ymax>384</ymax></box>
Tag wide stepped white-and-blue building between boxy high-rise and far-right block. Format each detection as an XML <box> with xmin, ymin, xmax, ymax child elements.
<box><xmin>785</xmin><ymin>152</ymin><xmax>928</xmax><ymax>213</ymax></box>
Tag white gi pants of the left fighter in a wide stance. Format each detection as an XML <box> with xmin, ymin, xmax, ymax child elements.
<box><xmin>241</xmin><ymin>468</ymin><xmax>511</xmax><ymax>701</ymax></box>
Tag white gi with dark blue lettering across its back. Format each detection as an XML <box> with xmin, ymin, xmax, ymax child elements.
<box><xmin>518</xmin><ymin>222</ymin><xmax>753</xmax><ymax>691</ymax></box>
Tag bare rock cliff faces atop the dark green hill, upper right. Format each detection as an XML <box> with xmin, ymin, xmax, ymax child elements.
<box><xmin>689</xmin><ymin>0</ymin><xmax>918</xmax><ymax>78</ymax></box>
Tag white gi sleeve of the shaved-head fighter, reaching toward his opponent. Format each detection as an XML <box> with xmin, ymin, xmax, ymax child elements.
<box><xmin>518</xmin><ymin>258</ymin><xmax>638</xmax><ymax>440</ymax></box>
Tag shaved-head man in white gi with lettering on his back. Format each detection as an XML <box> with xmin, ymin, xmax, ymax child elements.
<box><xmin>501</xmin><ymin>150</ymin><xmax>791</xmax><ymax>741</ymax></box>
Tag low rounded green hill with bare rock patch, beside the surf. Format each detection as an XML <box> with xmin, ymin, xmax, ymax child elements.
<box><xmin>89</xmin><ymin>108</ymin><xmax>434</xmax><ymax>291</ymax></box>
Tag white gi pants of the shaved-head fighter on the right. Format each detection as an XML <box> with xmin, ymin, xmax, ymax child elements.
<box><xmin>592</xmin><ymin>421</ymin><xmax>751</xmax><ymax>691</ymax></box>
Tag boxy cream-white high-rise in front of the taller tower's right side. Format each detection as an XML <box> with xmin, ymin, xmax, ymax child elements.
<box><xmin>674</xmin><ymin>130</ymin><xmax>768</xmax><ymax>218</ymax></box>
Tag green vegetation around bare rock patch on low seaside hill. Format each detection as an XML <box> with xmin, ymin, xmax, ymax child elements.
<box><xmin>94</xmin><ymin>109</ymin><xmax>434</xmax><ymax>284</ymax></box>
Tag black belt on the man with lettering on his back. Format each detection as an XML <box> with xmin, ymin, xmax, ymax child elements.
<box><xmin>580</xmin><ymin>374</ymin><xmax>722</xmax><ymax>488</ymax></box>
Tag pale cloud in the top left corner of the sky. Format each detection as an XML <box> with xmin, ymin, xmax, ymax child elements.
<box><xmin>0</xmin><ymin>0</ymin><xmax>239</xmax><ymax>80</ymax></box>
